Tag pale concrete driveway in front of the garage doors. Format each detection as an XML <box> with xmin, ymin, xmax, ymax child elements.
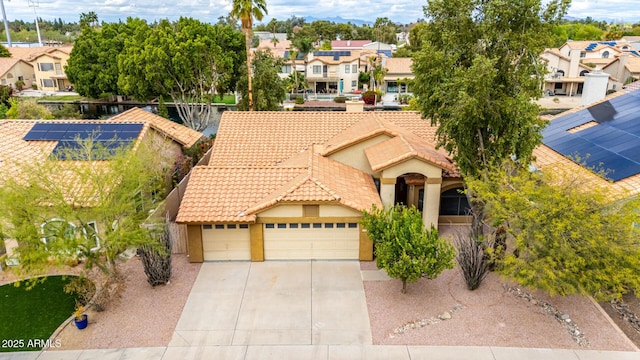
<box><xmin>169</xmin><ymin>261</ymin><xmax>372</xmax><ymax>347</ymax></box>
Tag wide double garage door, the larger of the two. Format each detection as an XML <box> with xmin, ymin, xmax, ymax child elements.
<box><xmin>264</xmin><ymin>223</ymin><xmax>360</xmax><ymax>260</ymax></box>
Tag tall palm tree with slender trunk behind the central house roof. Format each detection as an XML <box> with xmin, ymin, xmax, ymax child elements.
<box><xmin>229</xmin><ymin>0</ymin><xmax>267</xmax><ymax>111</ymax></box>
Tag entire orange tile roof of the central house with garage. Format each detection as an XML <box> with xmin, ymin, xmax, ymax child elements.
<box><xmin>176</xmin><ymin>111</ymin><xmax>459</xmax><ymax>223</ymax></box>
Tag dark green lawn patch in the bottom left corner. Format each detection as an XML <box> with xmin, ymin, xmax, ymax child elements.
<box><xmin>0</xmin><ymin>276</ymin><xmax>81</xmax><ymax>352</ymax></box>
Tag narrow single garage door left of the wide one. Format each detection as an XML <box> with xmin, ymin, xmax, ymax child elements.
<box><xmin>202</xmin><ymin>224</ymin><xmax>251</xmax><ymax>260</ymax></box>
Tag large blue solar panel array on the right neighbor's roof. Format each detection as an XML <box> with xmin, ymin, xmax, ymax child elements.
<box><xmin>542</xmin><ymin>90</ymin><xmax>640</xmax><ymax>181</ymax></box>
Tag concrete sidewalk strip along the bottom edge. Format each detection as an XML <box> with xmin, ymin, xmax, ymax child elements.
<box><xmin>8</xmin><ymin>345</ymin><xmax>640</xmax><ymax>360</ymax></box>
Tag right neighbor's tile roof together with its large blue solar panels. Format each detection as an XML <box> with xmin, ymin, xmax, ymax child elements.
<box><xmin>534</xmin><ymin>82</ymin><xmax>640</xmax><ymax>196</ymax></box>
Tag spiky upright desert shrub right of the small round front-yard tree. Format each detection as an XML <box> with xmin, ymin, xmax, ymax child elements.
<box><xmin>453</xmin><ymin>231</ymin><xmax>490</xmax><ymax>290</ymax></box>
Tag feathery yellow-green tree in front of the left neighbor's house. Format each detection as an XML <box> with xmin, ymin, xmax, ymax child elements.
<box><xmin>0</xmin><ymin>134</ymin><xmax>169</xmax><ymax>304</ymax></box>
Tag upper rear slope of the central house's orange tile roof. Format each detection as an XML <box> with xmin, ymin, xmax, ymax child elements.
<box><xmin>209</xmin><ymin>111</ymin><xmax>436</xmax><ymax>166</ymax></box>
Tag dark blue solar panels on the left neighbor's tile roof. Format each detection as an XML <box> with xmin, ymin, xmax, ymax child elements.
<box><xmin>23</xmin><ymin>122</ymin><xmax>143</xmax><ymax>160</ymax></box>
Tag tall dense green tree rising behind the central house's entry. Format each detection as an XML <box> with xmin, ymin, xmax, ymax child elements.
<box><xmin>413</xmin><ymin>0</ymin><xmax>569</xmax><ymax>175</ymax></box>
